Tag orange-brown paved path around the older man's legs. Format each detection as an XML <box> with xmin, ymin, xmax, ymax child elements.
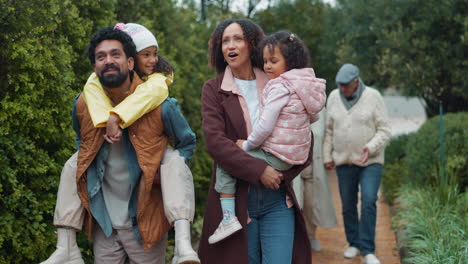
<box><xmin>312</xmin><ymin>172</ymin><xmax>400</xmax><ymax>264</ymax></box>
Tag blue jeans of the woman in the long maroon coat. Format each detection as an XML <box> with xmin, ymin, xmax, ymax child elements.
<box><xmin>247</xmin><ymin>185</ymin><xmax>295</xmax><ymax>264</ymax></box>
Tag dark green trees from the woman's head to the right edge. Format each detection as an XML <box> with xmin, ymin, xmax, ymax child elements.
<box><xmin>254</xmin><ymin>0</ymin><xmax>468</xmax><ymax>112</ymax></box>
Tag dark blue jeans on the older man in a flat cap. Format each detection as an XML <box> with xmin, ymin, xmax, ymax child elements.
<box><xmin>336</xmin><ymin>163</ymin><xmax>382</xmax><ymax>255</ymax></box>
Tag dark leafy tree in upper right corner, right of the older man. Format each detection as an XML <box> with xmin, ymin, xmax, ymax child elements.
<box><xmin>378</xmin><ymin>0</ymin><xmax>468</xmax><ymax>116</ymax></box>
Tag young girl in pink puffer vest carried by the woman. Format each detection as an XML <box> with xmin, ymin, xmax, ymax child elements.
<box><xmin>208</xmin><ymin>31</ymin><xmax>326</xmax><ymax>244</ymax></box>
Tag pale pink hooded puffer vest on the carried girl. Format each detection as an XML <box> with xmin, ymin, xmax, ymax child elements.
<box><xmin>262</xmin><ymin>68</ymin><xmax>326</xmax><ymax>165</ymax></box>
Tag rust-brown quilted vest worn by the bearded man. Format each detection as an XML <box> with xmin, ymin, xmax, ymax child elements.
<box><xmin>76</xmin><ymin>74</ymin><xmax>171</xmax><ymax>248</ymax></box>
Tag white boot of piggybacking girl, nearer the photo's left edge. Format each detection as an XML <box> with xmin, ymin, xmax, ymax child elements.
<box><xmin>41</xmin><ymin>228</ymin><xmax>84</xmax><ymax>264</ymax></box>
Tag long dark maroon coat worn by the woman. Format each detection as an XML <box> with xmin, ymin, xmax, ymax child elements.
<box><xmin>198</xmin><ymin>70</ymin><xmax>313</xmax><ymax>264</ymax></box>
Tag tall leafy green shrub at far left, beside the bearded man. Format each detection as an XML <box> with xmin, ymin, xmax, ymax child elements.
<box><xmin>0</xmin><ymin>0</ymin><xmax>91</xmax><ymax>263</ymax></box>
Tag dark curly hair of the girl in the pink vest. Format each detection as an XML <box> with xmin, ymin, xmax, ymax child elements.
<box><xmin>258</xmin><ymin>31</ymin><xmax>310</xmax><ymax>71</ymax></box>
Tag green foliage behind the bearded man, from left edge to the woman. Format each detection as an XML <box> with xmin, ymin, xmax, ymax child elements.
<box><xmin>0</xmin><ymin>0</ymin><xmax>213</xmax><ymax>263</ymax></box>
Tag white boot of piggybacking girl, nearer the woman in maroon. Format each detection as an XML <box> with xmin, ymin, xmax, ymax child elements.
<box><xmin>172</xmin><ymin>219</ymin><xmax>200</xmax><ymax>264</ymax></box>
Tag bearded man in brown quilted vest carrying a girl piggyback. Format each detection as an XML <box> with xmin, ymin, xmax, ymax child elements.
<box><xmin>73</xmin><ymin>27</ymin><xmax>185</xmax><ymax>264</ymax></box>
